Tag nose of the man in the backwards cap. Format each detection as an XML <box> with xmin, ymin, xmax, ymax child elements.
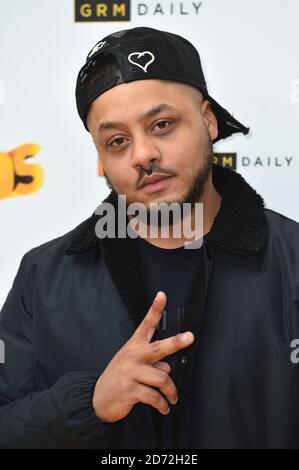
<box><xmin>131</xmin><ymin>135</ymin><xmax>161</xmax><ymax>170</ymax></box>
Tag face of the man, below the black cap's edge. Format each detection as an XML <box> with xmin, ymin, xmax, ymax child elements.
<box><xmin>87</xmin><ymin>80</ymin><xmax>217</xmax><ymax>212</ymax></box>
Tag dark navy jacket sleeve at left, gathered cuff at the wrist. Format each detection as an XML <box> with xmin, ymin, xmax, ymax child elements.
<box><xmin>0</xmin><ymin>253</ymin><xmax>118</xmax><ymax>449</ymax></box>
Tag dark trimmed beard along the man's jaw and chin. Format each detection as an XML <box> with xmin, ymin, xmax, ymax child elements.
<box><xmin>103</xmin><ymin>131</ymin><xmax>213</xmax><ymax>228</ymax></box>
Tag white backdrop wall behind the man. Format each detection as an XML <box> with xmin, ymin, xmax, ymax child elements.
<box><xmin>0</xmin><ymin>0</ymin><xmax>299</xmax><ymax>306</ymax></box>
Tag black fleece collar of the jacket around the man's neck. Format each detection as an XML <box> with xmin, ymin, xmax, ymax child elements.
<box><xmin>66</xmin><ymin>165</ymin><xmax>266</xmax><ymax>255</ymax></box>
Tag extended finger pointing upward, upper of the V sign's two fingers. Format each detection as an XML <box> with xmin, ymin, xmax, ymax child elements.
<box><xmin>132</xmin><ymin>291</ymin><xmax>167</xmax><ymax>342</ymax></box>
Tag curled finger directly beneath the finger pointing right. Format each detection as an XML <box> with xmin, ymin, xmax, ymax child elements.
<box><xmin>135</xmin><ymin>365</ymin><xmax>178</xmax><ymax>405</ymax></box>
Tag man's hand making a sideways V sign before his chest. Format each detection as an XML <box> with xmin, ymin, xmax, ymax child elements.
<box><xmin>92</xmin><ymin>291</ymin><xmax>194</xmax><ymax>423</ymax></box>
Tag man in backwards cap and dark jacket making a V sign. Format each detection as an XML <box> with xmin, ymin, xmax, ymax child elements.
<box><xmin>0</xmin><ymin>24</ymin><xmax>299</xmax><ymax>449</ymax></box>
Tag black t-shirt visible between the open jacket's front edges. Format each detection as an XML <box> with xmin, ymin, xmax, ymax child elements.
<box><xmin>135</xmin><ymin>237</ymin><xmax>202</xmax><ymax>448</ymax></box>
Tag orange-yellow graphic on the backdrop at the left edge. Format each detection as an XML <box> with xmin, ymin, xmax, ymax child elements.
<box><xmin>0</xmin><ymin>144</ymin><xmax>44</xmax><ymax>199</ymax></box>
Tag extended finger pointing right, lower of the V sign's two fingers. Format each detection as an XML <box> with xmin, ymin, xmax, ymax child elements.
<box><xmin>139</xmin><ymin>331</ymin><xmax>194</xmax><ymax>364</ymax></box>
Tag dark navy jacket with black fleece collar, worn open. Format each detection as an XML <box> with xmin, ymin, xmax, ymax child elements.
<box><xmin>0</xmin><ymin>166</ymin><xmax>299</xmax><ymax>449</ymax></box>
